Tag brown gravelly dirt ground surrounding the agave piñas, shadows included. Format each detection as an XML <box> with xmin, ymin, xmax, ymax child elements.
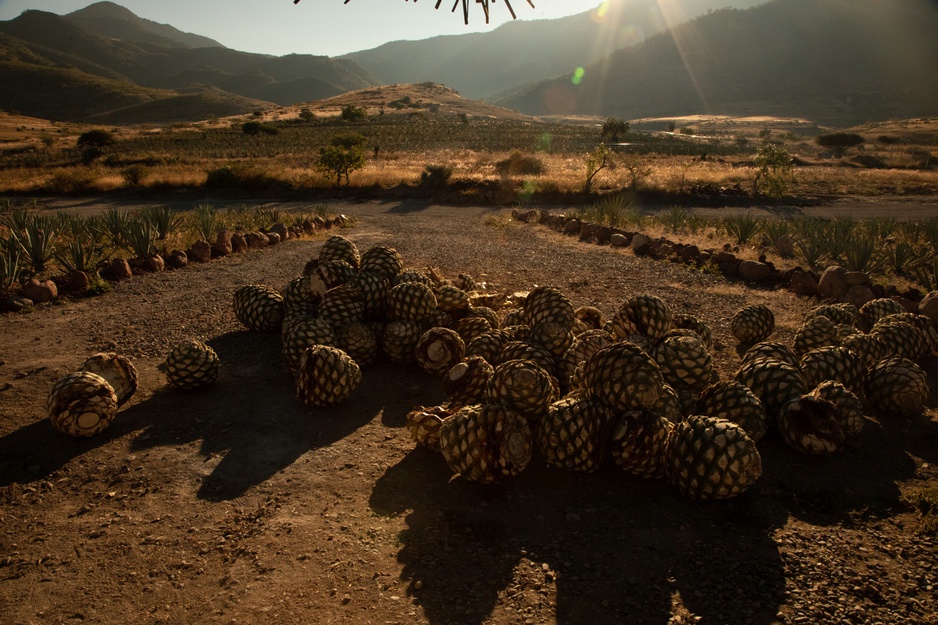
<box><xmin>0</xmin><ymin>203</ymin><xmax>938</xmax><ymax>625</ymax></box>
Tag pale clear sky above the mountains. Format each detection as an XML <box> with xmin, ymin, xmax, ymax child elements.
<box><xmin>0</xmin><ymin>0</ymin><xmax>601</xmax><ymax>56</ymax></box>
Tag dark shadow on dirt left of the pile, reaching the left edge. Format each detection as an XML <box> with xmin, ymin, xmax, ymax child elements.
<box><xmin>0</xmin><ymin>331</ymin><xmax>409</xmax><ymax>501</ymax></box>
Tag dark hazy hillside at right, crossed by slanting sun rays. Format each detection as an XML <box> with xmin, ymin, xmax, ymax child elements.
<box><xmin>496</xmin><ymin>0</ymin><xmax>938</xmax><ymax>126</ymax></box>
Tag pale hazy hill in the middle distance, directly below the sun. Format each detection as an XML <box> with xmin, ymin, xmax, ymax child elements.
<box><xmin>340</xmin><ymin>0</ymin><xmax>766</xmax><ymax>98</ymax></box>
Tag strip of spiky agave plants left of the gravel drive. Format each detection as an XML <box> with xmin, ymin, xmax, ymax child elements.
<box><xmin>0</xmin><ymin>201</ymin><xmax>336</xmax><ymax>295</ymax></box>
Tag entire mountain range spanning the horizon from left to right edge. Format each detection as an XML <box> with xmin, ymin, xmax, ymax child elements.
<box><xmin>0</xmin><ymin>0</ymin><xmax>938</xmax><ymax>126</ymax></box>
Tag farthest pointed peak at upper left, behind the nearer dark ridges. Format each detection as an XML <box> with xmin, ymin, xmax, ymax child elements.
<box><xmin>65</xmin><ymin>2</ymin><xmax>224</xmax><ymax>48</ymax></box>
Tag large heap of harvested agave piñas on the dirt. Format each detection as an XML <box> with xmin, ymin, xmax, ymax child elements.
<box><xmin>225</xmin><ymin>236</ymin><xmax>938</xmax><ymax>499</ymax></box>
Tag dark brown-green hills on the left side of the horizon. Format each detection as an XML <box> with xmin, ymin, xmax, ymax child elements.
<box><xmin>0</xmin><ymin>3</ymin><xmax>376</xmax><ymax>123</ymax></box>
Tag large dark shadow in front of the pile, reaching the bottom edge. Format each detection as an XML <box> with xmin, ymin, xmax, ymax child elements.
<box><xmin>370</xmin><ymin>449</ymin><xmax>785</xmax><ymax>625</ymax></box>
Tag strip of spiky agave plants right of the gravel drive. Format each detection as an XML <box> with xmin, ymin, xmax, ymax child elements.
<box><xmin>580</xmin><ymin>197</ymin><xmax>938</xmax><ymax>291</ymax></box>
